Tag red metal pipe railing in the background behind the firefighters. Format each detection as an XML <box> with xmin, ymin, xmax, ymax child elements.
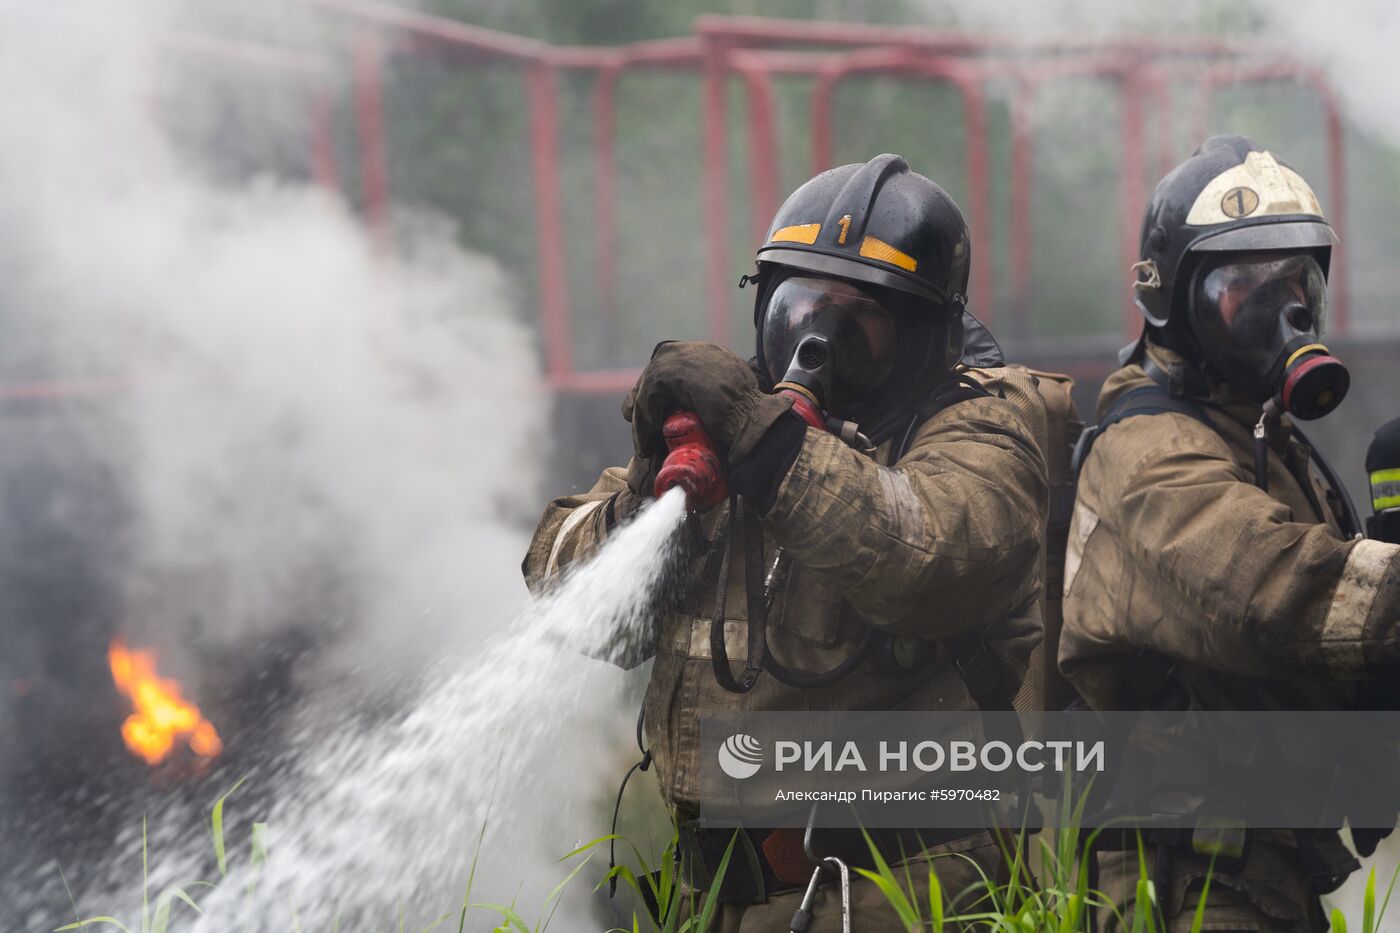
<box><xmin>0</xmin><ymin>0</ymin><xmax>1347</xmax><ymax>395</ymax></box>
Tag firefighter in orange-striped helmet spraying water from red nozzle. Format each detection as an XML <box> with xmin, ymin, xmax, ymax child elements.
<box><xmin>524</xmin><ymin>154</ymin><xmax>1046</xmax><ymax>933</ymax></box>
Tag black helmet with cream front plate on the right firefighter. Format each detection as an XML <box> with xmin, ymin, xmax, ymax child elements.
<box><xmin>1133</xmin><ymin>136</ymin><xmax>1337</xmax><ymax>326</ymax></box>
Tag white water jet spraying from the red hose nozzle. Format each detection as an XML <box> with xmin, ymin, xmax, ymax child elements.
<box><xmin>191</xmin><ymin>490</ymin><xmax>685</xmax><ymax>933</ymax></box>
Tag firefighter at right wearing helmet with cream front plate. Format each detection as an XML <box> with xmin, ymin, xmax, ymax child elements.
<box><xmin>1058</xmin><ymin>136</ymin><xmax>1400</xmax><ymax>932</ymax></box>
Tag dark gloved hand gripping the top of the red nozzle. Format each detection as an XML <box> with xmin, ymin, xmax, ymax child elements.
<box><xmin>623</xmin><ymin>340</ymin><xmax>792</xmax><ymax>473</ymax></box>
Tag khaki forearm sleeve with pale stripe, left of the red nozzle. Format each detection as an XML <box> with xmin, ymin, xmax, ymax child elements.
<box><xmin>521</xmin><ymin>467</ymin><xmax>636</xmax><ymax>595</ymax></box>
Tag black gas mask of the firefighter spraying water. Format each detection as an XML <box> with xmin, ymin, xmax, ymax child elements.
<box><xmin>760</xmin><ymin>276</ymin><xmax>899</xmax><ymax>416</ymax></box>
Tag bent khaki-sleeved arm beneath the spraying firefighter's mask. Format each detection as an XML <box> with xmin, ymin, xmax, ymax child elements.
<box><xmin>764</xmin><ymin>389</ymin><xmax>1047</xmax><ymax>637</ymax></box>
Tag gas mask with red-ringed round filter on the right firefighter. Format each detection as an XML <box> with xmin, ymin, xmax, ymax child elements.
<box><xmin>1190</xmin><ymin>252</ymin><xmax>1351</xmax><ymax>420</ymax></box>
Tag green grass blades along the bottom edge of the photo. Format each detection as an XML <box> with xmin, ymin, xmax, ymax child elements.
<box><xmin>40</xmin><ymin>780</ymin><xmax>1400</xmax><ymax>933</ymax></box>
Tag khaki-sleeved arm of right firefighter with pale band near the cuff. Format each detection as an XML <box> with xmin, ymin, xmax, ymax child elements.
<box><xmin>1077</xmin><ymin>416</ymin><xmax>1400</xmax><ymax>679</ymax></box>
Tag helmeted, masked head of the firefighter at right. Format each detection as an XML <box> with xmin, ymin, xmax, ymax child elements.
<box><xmin>1133</xmin><ymin>136</ymin><xmax>1351</xmax><ymax>419</ymax></box>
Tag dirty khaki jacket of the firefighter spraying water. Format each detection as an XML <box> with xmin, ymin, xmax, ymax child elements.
<box><xmin>524</xmin><ymin>368</ymin><xmax>1047</xmax><ymax>818</ymax></box>
